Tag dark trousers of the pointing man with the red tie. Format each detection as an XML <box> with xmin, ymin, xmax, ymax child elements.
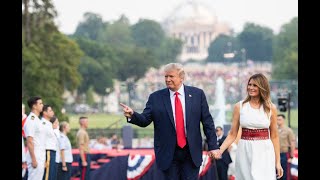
<box><xmin>163</xmin><ymin>144</ymin><xmax>200</xmax><ymax>180</ymax></box>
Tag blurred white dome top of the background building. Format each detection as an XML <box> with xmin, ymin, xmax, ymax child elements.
<box><xmin>164</xmin><ymin>1</ymin><xmax>217</xmax><ymax>26</ymax></box>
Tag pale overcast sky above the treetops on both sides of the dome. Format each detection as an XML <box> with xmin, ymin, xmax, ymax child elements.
<box><xmin>53</xmin><ymin>0</ymin><xmax>298</xmax><ymax>34</ymax></box>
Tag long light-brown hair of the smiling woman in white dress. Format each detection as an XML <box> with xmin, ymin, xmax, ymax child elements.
<box><xmin>242</xmin><ymin>73</ymin><xmax>271</xmax><ymax>114</ymax></box>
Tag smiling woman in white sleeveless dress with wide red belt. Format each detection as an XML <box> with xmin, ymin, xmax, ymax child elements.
<box><xmin>214</xmin><ymin>73</ymin><xmax>283</xmax><ymax>180</ymax></box>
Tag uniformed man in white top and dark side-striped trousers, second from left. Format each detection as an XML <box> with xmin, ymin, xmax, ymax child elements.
<box><xmin>41</xmin><ymin>104</ymin><xmax>58</xmax><ymax>180</ymax></box>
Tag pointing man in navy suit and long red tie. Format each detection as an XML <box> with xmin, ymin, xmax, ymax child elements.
<box><xmin>120</xmin><ymin>63</ymin><xmax>220</xmax><ymax>180</ymax></box>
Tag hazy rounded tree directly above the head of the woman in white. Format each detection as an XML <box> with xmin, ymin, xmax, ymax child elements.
<box><xmin>237</xmin><ymin>23</ymin><xmax>273</xmax><ymax>61</ymax></box>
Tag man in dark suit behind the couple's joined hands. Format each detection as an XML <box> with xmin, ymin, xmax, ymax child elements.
<box><xmin>216</xmin><ymin>126</ymin><xmax>232</xmax><ymax>180</ymax></box>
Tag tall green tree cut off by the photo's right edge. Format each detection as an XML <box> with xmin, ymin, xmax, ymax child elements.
<box><xmin>272</xmin><ymin>17</ymin><xmax>298</xmax><ymax>80</ymax></box>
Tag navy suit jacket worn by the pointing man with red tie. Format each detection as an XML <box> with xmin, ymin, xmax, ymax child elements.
<box><xmin>129</xmin><ymin>86</ymin><xmax>219</xmax><ymax>170</ymax></box>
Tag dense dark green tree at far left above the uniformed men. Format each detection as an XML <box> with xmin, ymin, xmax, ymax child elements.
<box><xmin>22</xmin><ymin>28</ymin><xmax>82</xmax><ymax>118</ymax></box>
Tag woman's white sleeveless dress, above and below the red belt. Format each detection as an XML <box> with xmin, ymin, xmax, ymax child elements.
<box><xmin>235</xmin><ymin>101</ymin><xmax>276</xmax><ymax>180</ymax></box>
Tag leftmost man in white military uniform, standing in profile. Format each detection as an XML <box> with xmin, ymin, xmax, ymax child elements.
<box><xmin>24</xmin><ymin>97</ymin><xmax>46</xmax><ymax>180</ymax></box>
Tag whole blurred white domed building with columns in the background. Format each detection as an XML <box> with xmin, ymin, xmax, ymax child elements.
<box><xmin>162</xmin><ymin>0</ymin><xmax>230</xmax><ymax>62</ymax></box>
